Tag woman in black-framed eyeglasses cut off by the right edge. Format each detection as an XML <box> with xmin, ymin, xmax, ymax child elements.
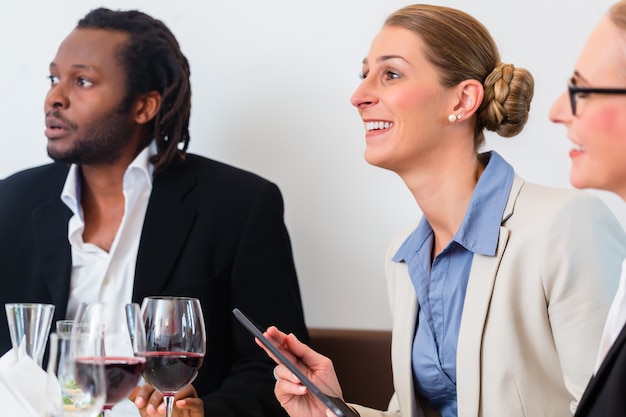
<box><xmin>550</xmin><ymin>1</ymin><xmax>626</xmax><ymax>417</ymax></box>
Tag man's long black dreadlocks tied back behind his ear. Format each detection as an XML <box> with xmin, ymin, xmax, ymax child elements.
<box><xmin>77</xmin><ymin>8</ymin><xmax>191</xmax><ymax>174</ymax></box>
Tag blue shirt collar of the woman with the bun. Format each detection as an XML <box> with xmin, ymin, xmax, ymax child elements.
<box><xmin>393</xmin><ymin>151</ymin><xmax>515</xmax><ymax>262</ymax></box>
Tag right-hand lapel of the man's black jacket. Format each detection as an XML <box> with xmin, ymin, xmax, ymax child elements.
<box><xmin>133</xmin><ymin>160</ymin><xmax>197</xmax><ymax>302</ymax></box>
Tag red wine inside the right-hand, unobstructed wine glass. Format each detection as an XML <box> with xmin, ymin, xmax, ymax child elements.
<box><xmin>145</xmin><ymin>352</ymin><xmax>204</xmax><ymax>395</ymax></box>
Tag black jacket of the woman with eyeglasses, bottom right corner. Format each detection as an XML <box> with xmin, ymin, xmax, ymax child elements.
<box><xmin>574</xmin><ymin>320</ymin><xmax>626</xmax><ymax>417</ymax></box>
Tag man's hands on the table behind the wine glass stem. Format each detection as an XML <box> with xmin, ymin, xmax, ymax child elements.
<box><xmin>128</xmin><ymin>384</ymin><xmax>204</xmax><ymax>417</ymax></box>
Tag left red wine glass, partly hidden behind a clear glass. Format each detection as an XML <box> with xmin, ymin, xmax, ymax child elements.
<box><xmin>75</xmin><ymin>303</ymin><xmax>146</xmax><ymax>417</ymax></box>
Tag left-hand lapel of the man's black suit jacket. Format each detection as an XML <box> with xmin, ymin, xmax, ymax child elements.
<box><xmin>31</xmin><ymin>169</ymin><xmax>72</xmax><ymax>317</ymax></box>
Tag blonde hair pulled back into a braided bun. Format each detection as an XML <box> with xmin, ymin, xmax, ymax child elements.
<box><xmin>384</xmin><ymin>4</ymin><xmax>534</xmax><ymax>150</ymax></box>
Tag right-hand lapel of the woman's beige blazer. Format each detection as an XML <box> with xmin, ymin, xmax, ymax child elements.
<box><xmin>457</xmin><ymin>176</ymin><xmax>524</xmax><ymax>417</ymax></box>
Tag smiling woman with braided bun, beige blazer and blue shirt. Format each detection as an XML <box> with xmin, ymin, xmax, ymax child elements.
<box><xmin>260</xmin><ymin>5</ymin><xmax>626</xmax><ymax>417</ymax></box>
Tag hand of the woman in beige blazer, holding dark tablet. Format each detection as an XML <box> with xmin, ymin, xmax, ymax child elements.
<box><xmin>257</xmin><ymin>326</ymin><xmax>343</xmax><ymax>417</ymax></box>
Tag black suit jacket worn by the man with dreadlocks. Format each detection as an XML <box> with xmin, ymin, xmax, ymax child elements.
<box><xmin>0</xmin><ymin>155</ymin><xmax>308</xmax><ymax>416</ymax></box>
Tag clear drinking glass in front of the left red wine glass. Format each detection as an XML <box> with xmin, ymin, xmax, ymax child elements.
<box><xmin>46</xmin><ymin>322</ymin><xmax>106</xmax><ymax>417</ymax></box>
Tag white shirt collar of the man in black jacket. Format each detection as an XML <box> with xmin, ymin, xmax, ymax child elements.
<box><xmin>61</xmin><ymin>140</ymin><xmax>157</xmax><ymax>219</ymax></box>
